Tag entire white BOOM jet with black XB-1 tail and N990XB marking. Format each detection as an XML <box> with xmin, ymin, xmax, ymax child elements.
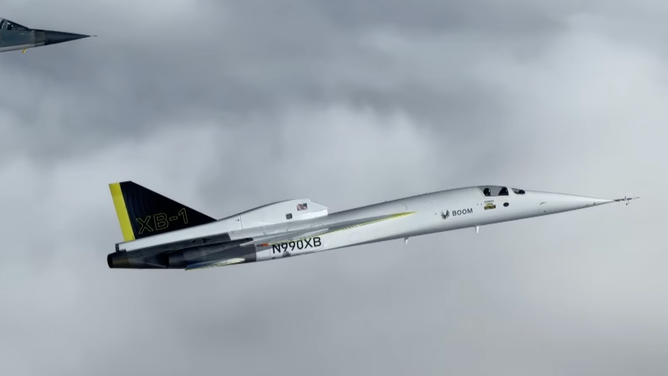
<box><xmin>107</xmin><ymin>181</ymin><xmax>637</xmax><ymax>270</ymax></box>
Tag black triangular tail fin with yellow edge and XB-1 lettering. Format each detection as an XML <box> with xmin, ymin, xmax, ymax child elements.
<box><xmin>109</xmin><ymin>181</ymin><xmax>215</xmax><ymax>242</ymax></box>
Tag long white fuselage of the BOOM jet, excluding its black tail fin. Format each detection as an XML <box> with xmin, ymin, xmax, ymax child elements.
<box><xmin>108</xmin><ymin>186</ymin><xmax>632</xmax><ymax>269</ymax></box>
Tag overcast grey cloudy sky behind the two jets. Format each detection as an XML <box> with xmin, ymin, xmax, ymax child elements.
<box><xmin>0</xmin><ymin>0</ymin><xmax>668</xmax><ymax>376</ymax></box>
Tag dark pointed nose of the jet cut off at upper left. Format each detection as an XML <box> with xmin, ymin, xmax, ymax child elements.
<box><xmin>0</xmin><ymin>18</ymin><xmax>91</xmax><ymax>53</ymax></box>
